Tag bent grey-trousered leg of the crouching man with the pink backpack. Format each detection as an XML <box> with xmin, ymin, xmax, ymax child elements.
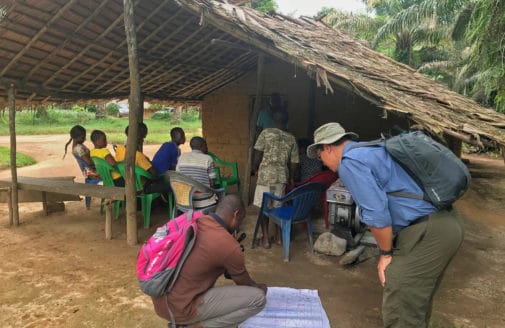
<box><xmin>193</xmin><ymin>286</ymin><xmax>266</xmax><ymax>328</ymax></box>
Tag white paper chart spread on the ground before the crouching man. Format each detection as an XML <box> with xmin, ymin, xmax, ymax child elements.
<box><xmin>239</xmin><ymin>287</ymin><xmax>330</xmax><ymax>328</ymax></box>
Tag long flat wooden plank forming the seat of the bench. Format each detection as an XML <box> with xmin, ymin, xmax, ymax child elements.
<box><xmin>0</xmin><ymin>177</ymin><xmax>125</xmax><ymax>200</ymax></box>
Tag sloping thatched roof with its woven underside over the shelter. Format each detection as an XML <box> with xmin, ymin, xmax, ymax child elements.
<box><xmin>0</xmin><ymin>0</ymin><xmax>505</xmax><ymax>146</ymax></box>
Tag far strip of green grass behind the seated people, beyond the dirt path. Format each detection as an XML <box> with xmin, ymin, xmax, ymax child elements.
<box><xmin>0</xmin><ymin>108</ymin><xmax>202</xmax><ymax>144</ymax></box>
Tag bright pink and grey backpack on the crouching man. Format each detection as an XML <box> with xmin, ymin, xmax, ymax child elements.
<box><xmin>137</xmin><ymin>211</ymin><xmax>203</xmax><ymax>297</ymax></box>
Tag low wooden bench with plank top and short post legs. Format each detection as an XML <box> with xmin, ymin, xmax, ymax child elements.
<box><xmin>0</xmin><ymin>177</ymin><xmax>125</xmax><ymax>239</ymax></box>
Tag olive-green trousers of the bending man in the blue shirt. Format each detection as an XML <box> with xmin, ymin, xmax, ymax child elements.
<box><xmin>382</xmin><ymin>213</ymin><xmax>463</xmax><ymax>328</ymax></box>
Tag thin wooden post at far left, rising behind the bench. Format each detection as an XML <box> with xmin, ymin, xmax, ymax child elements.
<box><xmin>7</xmin><ymin>83</ymin><xmax>19</xmax><ymax>227</ymax></box>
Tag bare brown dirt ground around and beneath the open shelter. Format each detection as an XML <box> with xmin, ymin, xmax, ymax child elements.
<box><xmin>0</xmin><ymin>135</ymin><xmax>505</xmax><ymax>328</ymax></box>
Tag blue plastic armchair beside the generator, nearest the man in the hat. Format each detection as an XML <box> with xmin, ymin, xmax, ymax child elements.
<box><xmin>252</xmin><ymin>182</ymin><xmax>326</xmax><ymax>262</ymax></box>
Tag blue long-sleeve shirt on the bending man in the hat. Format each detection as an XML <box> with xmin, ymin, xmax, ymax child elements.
<box><xmin>338</xmin><ymin>142</ymin><xmax>436</xmax><ymax>234</ymax></box>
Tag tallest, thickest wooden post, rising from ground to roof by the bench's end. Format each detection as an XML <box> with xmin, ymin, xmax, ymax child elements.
<box><xmin>123</xmin><ymin>0</ymin><xmax>141</xmax><ymax>246</ymax></box>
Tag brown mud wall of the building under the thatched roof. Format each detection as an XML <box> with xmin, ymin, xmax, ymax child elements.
<box><xmin>202</xmin><ymin>58</ymin><xmax>405</xmax><ymax>197</ymax></box>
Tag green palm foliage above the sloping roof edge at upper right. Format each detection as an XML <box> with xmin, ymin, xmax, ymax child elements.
<box><xmin>318</xmin><ymin>0</ymin><xmax>505</xmax><ymax>113</ymax></box>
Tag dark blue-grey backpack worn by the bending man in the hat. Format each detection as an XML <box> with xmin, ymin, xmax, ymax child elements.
<box><xmin>350</xmin><ymin>131</ymin><xmax>470</xmax><ymax>210</ymax></box>
